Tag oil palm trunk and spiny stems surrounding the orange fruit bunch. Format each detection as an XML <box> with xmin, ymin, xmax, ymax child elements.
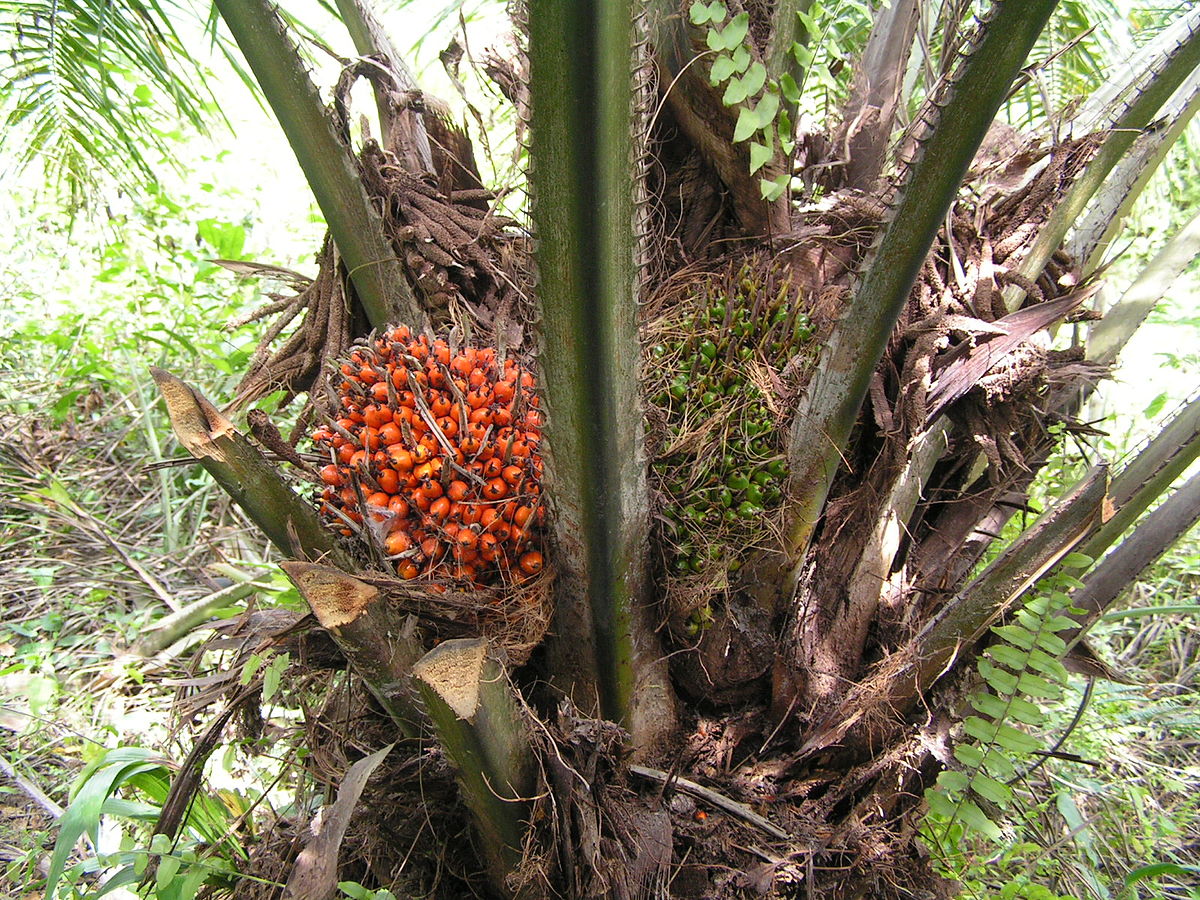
<box><xmin>16</xmin><ymin>0</ymin><xmax>1200</xmax><ymax>896</ymax></box>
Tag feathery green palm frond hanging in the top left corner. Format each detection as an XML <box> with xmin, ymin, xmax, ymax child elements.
<box><xmin>0</xmin><ymin>0</ymin><xmax>215</xmax><ymax>196</ymax></box>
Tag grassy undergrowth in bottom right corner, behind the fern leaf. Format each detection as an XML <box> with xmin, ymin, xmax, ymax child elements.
<box><xmin>925</xmin><ymin>539</ymin><xmax>1200</xmax><ymax>900</ymax></box>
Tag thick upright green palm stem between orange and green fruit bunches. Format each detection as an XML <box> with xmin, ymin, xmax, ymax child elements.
<box><xmin>529</xmin><ymin>0</ymin><xmax>674</xmax><ymax>746</ymax></box>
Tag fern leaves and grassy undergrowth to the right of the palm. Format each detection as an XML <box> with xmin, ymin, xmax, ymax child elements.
<box><xmin>907</xmin><ymin>392</ymin><xmax>1200</xmax><ymax>900</ymax></box>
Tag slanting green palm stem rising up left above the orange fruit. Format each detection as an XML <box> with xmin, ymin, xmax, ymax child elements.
<box><xmin>216</xmin><ymin>0</ymin><xmax>421</xmax><ymax>328</ymax></box>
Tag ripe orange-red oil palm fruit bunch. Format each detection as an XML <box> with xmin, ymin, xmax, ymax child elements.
<box><xmin>312</xmin><ymin>325</ymin><xmax>545</xmax><ymax>584</ymax></box>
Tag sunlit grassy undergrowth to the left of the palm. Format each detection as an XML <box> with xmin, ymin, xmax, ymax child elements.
<box><xmin>0</xmin><ymin>168</ymin><xmax>319</xmax><ymax>896</ymax></box>
